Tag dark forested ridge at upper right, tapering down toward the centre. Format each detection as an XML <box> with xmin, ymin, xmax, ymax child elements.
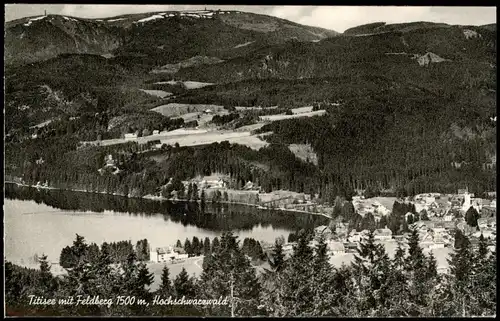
<box><xmin>176</xmin><ymin>23</ymin><xmax>496</xmax><ymax>83</ymax></box>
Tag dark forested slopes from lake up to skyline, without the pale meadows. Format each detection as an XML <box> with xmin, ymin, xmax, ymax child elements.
<box><xmin>5</xmin><ymin>12</ymin><xmax>496</xmax><ymax>200</ymax></box>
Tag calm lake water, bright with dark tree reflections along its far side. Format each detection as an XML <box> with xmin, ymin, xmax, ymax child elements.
<box><xmin>4</xmin><ymin>184</ymin><xmax>332</xmax><ymax>264</ymax></box>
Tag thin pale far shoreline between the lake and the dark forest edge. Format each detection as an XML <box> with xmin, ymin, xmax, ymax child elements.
<box><xmin>4</xmin><ymin>181</ymin><xmax>331</xmax><ymax>219</ymax></box>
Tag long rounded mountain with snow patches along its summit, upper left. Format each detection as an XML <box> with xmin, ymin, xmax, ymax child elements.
<box><xmin>5</xmin><ymin>10</ymin><xmax>338</xmax><ymax>66</ymax></box>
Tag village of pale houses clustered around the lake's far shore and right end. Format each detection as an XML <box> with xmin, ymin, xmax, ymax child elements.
<box><xmin>146</xmin><ymin>175</ymin><xmax>496</xmax><ymax>273</ymax></box>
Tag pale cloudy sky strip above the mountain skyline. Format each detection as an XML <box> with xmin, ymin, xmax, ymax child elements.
<box><xmin>5</xmin><ymin>4</ymin><xmax>496</xmax><ymax>32</ymax></box>
